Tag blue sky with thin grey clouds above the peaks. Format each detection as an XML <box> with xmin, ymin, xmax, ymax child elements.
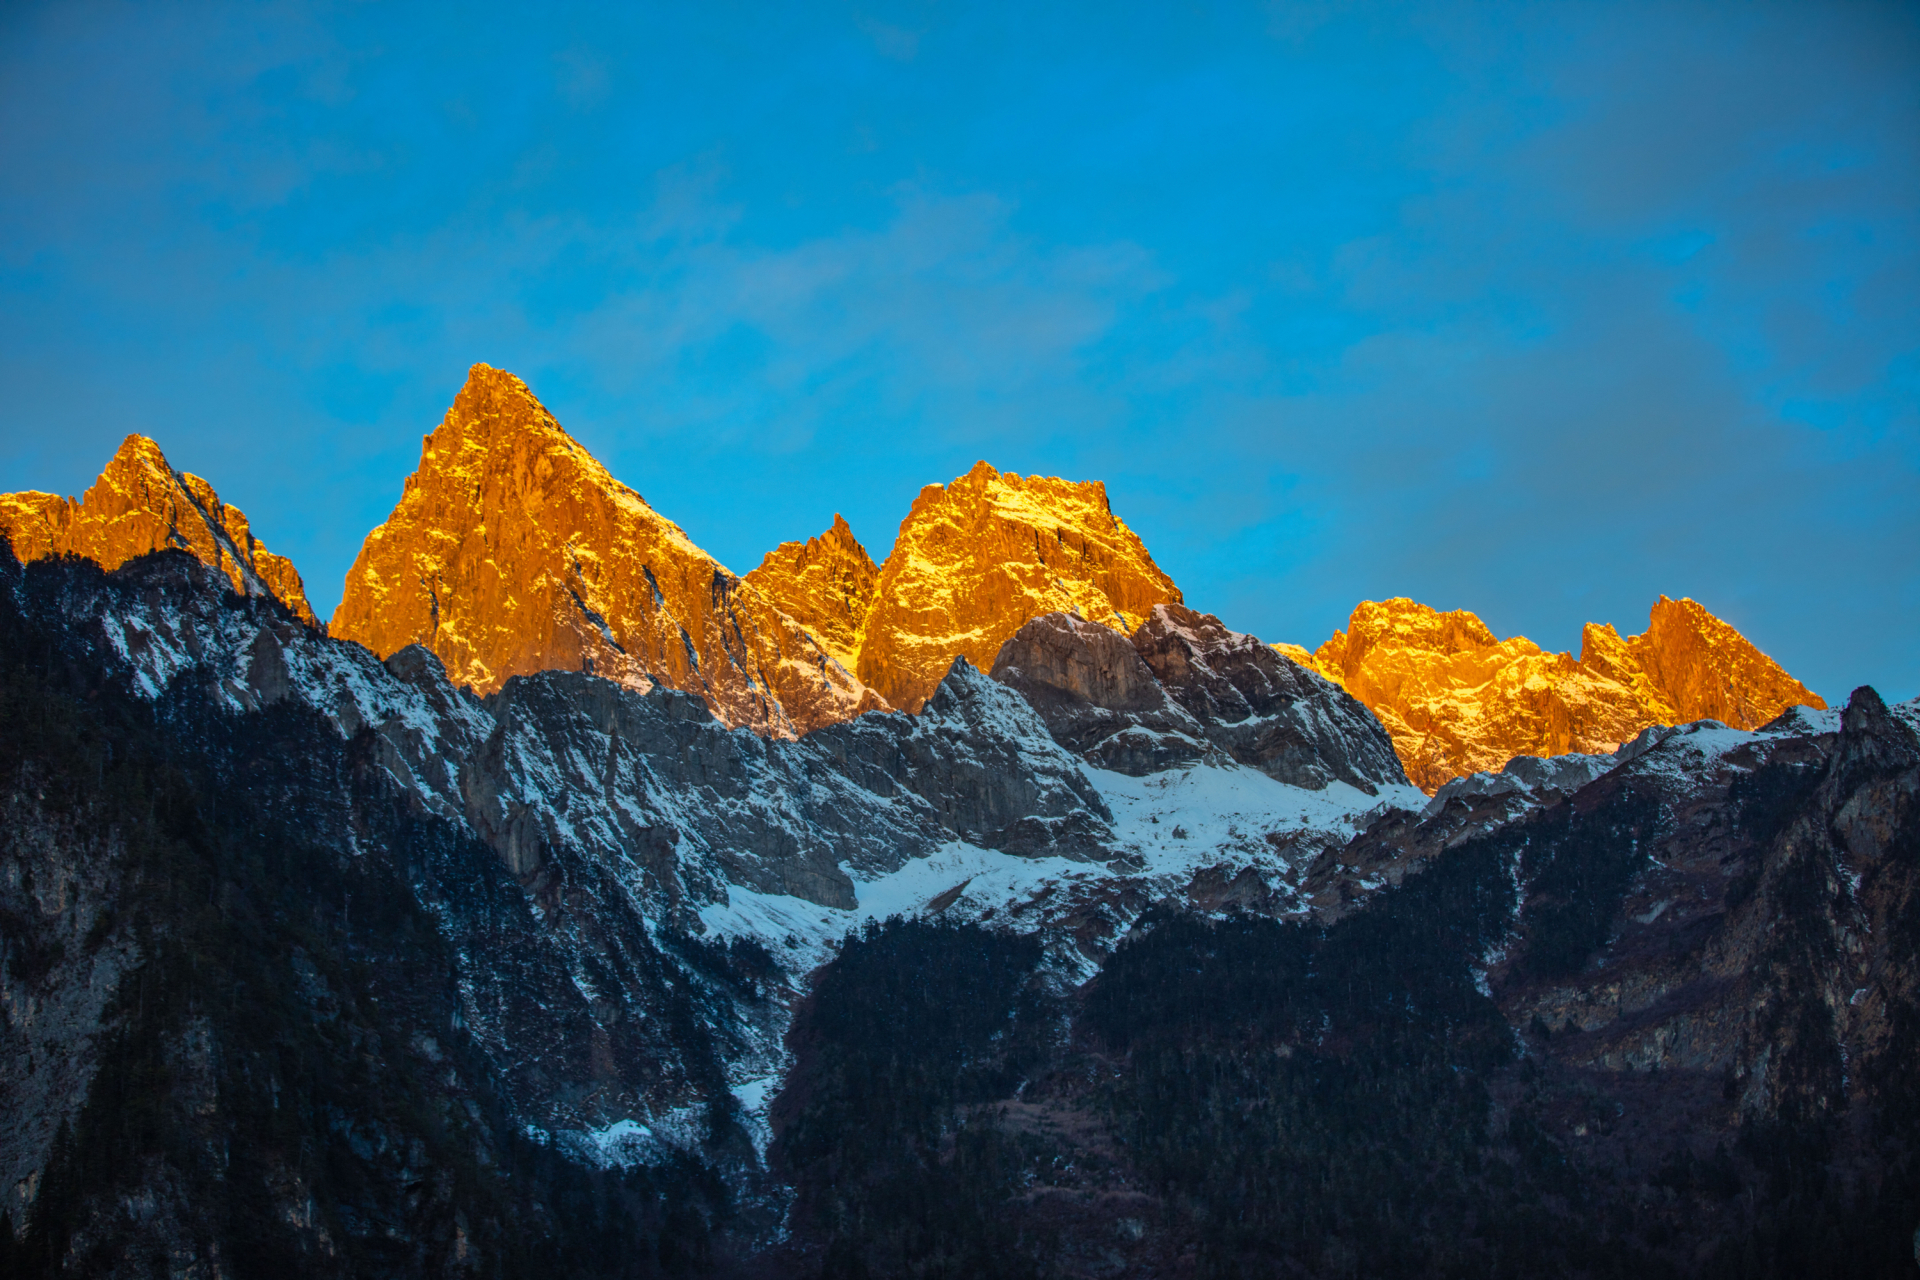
<box><xmin>0</xmin><ymin>0</ymin><xmax>1920</xmax><ymax>699</ymax></box>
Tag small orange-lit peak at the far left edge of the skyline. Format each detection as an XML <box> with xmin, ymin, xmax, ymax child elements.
<box><xmin>0</xmin><ymin>436</ymin><xmax>315</xmax><ymax>622</ymax></box>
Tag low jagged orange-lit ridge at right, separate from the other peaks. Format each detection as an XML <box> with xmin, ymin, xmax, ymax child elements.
<box><xmin>1279</xmin><ymin>595</ymin><xmax>1826</xmax><ymax>793</ymax></box>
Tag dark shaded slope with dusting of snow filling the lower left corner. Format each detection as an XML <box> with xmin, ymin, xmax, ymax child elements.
<box><xmin>0</xmin><ymin>545</ymin><xmax>760</xmax><ymax>1276</ymax></box>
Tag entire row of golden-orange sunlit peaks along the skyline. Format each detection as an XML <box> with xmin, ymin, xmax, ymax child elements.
<box><xmin>0</xmin><ymin>365</ymin><xmax>1826</xmax><ymax>793</ymax></box>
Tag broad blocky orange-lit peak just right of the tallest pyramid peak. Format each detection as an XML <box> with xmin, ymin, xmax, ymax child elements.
<box><xmin>858</xmin><ymin>462</ymin><xmax>1181</xmax><ymax>710</ymax></box>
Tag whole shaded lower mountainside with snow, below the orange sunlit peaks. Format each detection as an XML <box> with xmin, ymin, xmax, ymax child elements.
<box><xmin>0</xmin><ymin>553</ymin><xmax>1920</xmax><ymax>1276</ymax></box>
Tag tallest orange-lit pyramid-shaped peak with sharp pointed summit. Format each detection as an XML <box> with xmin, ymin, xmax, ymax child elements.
<box><xmin>332</xmin><ymin>365</ymin><xmax>879</xmax><ymax>737</ymax></box>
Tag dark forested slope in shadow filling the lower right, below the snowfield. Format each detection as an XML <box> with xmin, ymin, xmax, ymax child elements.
<box><xmin>776</xmin><ymin>689</ymin><xmax>1920</xmax><ymax>1278</ymax></box>
